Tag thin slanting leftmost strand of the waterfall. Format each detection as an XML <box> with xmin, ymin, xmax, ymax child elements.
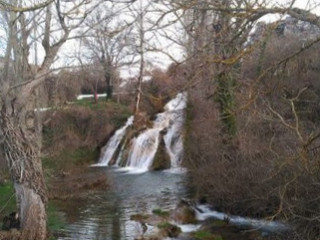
<box><xmin>93</xmin><ymin>116</ymin><xmax>133</xmax><ymax>166</ymax></box>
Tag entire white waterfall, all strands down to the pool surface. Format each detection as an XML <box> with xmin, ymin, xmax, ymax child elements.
<box><xmin>97</xmin><ymin>93</ymin><xmax>187</xmax><ymax>171</ymax></box>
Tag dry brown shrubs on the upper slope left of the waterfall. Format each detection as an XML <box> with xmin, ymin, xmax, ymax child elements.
<box><xmin>44</xmin><ymin>103</ymin><xmax>128</xmax><ymax>154</ymax></box>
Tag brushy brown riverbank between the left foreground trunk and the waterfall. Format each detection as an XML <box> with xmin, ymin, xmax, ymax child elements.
<box><xmin>0</xmin><ymin>99</ymin><xmax>130</xmax><ymax>240</ymax></box>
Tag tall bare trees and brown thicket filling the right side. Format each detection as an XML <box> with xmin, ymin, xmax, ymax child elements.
<box><xmin>160</xmin><ymin>1</ymin><xmax>320</xmax><ymax>236</ymax></box>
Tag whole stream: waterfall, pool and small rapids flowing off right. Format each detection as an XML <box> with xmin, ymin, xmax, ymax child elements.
<box><xmin>58</xmin><ymin>93</ymin><xmax>288</xmax><ymax>240</ymax></box>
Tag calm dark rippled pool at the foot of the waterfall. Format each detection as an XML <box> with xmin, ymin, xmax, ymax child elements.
<box><xmin>59</xmin><ymin>168</ymin><xmax>187</xmax><ymax>240</ymax></box>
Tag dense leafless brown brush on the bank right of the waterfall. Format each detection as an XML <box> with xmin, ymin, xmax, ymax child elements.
<box><xmin>186</xmin><ymin>30</ymin><xmax>320</xmax><ymax>239</ymax></box>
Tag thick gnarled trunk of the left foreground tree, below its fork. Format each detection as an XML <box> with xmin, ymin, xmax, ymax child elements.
<box><xmin>1</xmin><ymin>104</ymin><xmax>47</xmax><ymax>240</ymax></box>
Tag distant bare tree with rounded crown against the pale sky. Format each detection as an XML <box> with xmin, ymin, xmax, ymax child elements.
<box><xmin>82</xmin><ymin>3</ymin><xmax>134</xmax><ymax>100</ymax></box>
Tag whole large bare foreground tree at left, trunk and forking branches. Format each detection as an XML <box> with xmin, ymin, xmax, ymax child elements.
<box><xmin>0</xmin><ymin>0</ymin><xmax>100</xmax><ymax>240</ymax></box>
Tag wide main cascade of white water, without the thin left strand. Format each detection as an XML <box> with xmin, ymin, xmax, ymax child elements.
<box><xmin>127</xmin><ymin>93</ymin><xmax>187</xmax><ymax>171</ymax></box>
